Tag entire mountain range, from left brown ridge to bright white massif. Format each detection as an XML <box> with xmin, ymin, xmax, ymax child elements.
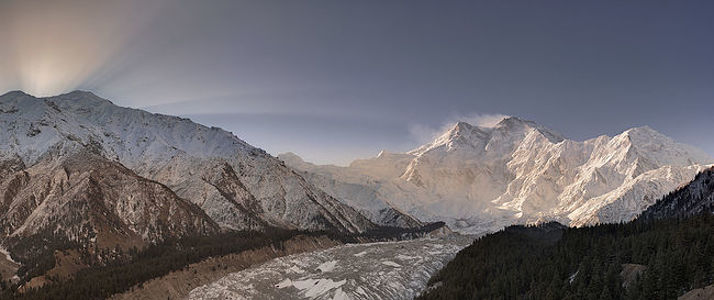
<box><xmin>0</xmin><ymin>91</ymin><xmax>714</xmax><ymax>300</ymax></box>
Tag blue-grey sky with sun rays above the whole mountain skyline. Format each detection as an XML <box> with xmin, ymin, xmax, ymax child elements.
<box><xmin>0</xmin><ymin>0</ymin><xmax>714</xmax><ymax>165</ymax></box>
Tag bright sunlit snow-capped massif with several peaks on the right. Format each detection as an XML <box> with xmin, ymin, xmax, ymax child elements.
<box><xmin>288</xmin><ymin>117</ymin><xmax>714</xmax><ymax>233</ymax></box>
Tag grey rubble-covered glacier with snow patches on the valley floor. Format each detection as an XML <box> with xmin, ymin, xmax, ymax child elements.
<box><xmin>189</xmin><ymin>236</ymin><xmax>472</xmax><ymax>300</ymax></box>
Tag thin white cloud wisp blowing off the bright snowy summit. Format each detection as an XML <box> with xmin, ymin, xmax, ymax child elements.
<box><xmin>408</xmin><ymin>113</ymin><xmax>509</xmax><ymax>144</ymax></box>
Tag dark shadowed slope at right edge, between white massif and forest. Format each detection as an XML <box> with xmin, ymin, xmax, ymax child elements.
<box><xmin>641</xmin><ymin>168</ymin><xmax>714</xmax><ymax>219</ymax></box>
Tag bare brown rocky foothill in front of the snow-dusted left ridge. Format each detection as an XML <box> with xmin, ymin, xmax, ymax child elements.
<box><xmin>0</xmin><ymin>151</ymin><xmax>219</xmax><ymax>248</ymax></box>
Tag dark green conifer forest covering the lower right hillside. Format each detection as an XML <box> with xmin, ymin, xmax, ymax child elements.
<box><xmin>419</xmin><ymin>213</ymin><xmax>714</xmax><ymax>300</ymax></box>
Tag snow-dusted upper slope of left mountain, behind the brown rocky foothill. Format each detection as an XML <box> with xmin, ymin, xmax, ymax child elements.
<box><xmin>0</xmin><ymin>91</ymin><xmax>374</xmax><ymax>237</ymax></box>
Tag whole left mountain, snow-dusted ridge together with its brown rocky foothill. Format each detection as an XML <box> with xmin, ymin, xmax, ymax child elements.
<box><xmin>0</xmin><ymin>92</ymin><xmax>374</xmax><ymax>253</ymax></box>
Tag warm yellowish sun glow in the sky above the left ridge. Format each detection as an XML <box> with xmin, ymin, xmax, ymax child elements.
<box><xmin>0</xmin><ymin>1</ymin><xmax>161</xmax><ymax>96</ymax></box>
